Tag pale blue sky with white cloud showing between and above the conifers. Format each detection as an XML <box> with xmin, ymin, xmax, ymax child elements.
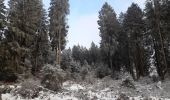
<box><xmin>5</xmin><ymin>0</ymin><xmax>145</xmax><ymax>48</ymax></box>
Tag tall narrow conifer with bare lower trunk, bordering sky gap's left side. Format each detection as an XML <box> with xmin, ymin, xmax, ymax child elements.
<box><xmin>49</xmin><ymin>0</ymin><xmax>69</xmax><ymax>65</ymax></box>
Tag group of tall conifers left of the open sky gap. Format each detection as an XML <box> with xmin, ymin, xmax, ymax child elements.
<box><xmin>0</xmin><ymin>0</ymin><xmax>69</xmax><ymax>80</ymax></box>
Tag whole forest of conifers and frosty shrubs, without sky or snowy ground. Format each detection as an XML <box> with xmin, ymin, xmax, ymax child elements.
<box><xmin>0</xmin><ymin>0</ymin><xmax>170</xmax><ymax>100</ymax></box>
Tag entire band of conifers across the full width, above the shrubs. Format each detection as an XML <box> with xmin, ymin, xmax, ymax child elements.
<box><xmin>0</xmin><ymin>0</ymin><xmax>170</xmax><ymax>81</ymax></box>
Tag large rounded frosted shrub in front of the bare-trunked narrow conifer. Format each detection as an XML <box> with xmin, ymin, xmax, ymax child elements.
<box><xmin>41</xmin><ymin>64</ymin><xmax>66</xmax><ymax>91</ymax></box>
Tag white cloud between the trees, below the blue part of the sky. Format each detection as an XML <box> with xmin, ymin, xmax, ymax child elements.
<box><xmin>67</xmin><ymin>13</ymin><xmax>100</xmax><ymax>48</ymax></box>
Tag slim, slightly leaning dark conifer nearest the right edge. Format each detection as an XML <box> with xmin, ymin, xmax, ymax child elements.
<box><xmin>153</xmin><ymin>0</ymin><xmax>167</xmax><ymax>80</ymax></box>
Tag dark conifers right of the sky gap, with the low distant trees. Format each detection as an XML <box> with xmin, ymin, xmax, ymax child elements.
<box><xmin>62</xmin><ymin>0</ymin><xmax>170</xmax><ymax>80</ymax></box>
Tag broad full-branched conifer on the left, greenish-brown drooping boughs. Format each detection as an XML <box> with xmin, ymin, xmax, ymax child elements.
<box><xmin>6</xmin><ymin>0</ymin><xmax>46</xmax><ymax>72</ymax></box>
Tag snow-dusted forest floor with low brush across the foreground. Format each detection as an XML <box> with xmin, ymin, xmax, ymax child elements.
<box><xmin>0</xmin><ymin>77</ymin><xmax>170</xmax><ymax>100</ymax></box>
